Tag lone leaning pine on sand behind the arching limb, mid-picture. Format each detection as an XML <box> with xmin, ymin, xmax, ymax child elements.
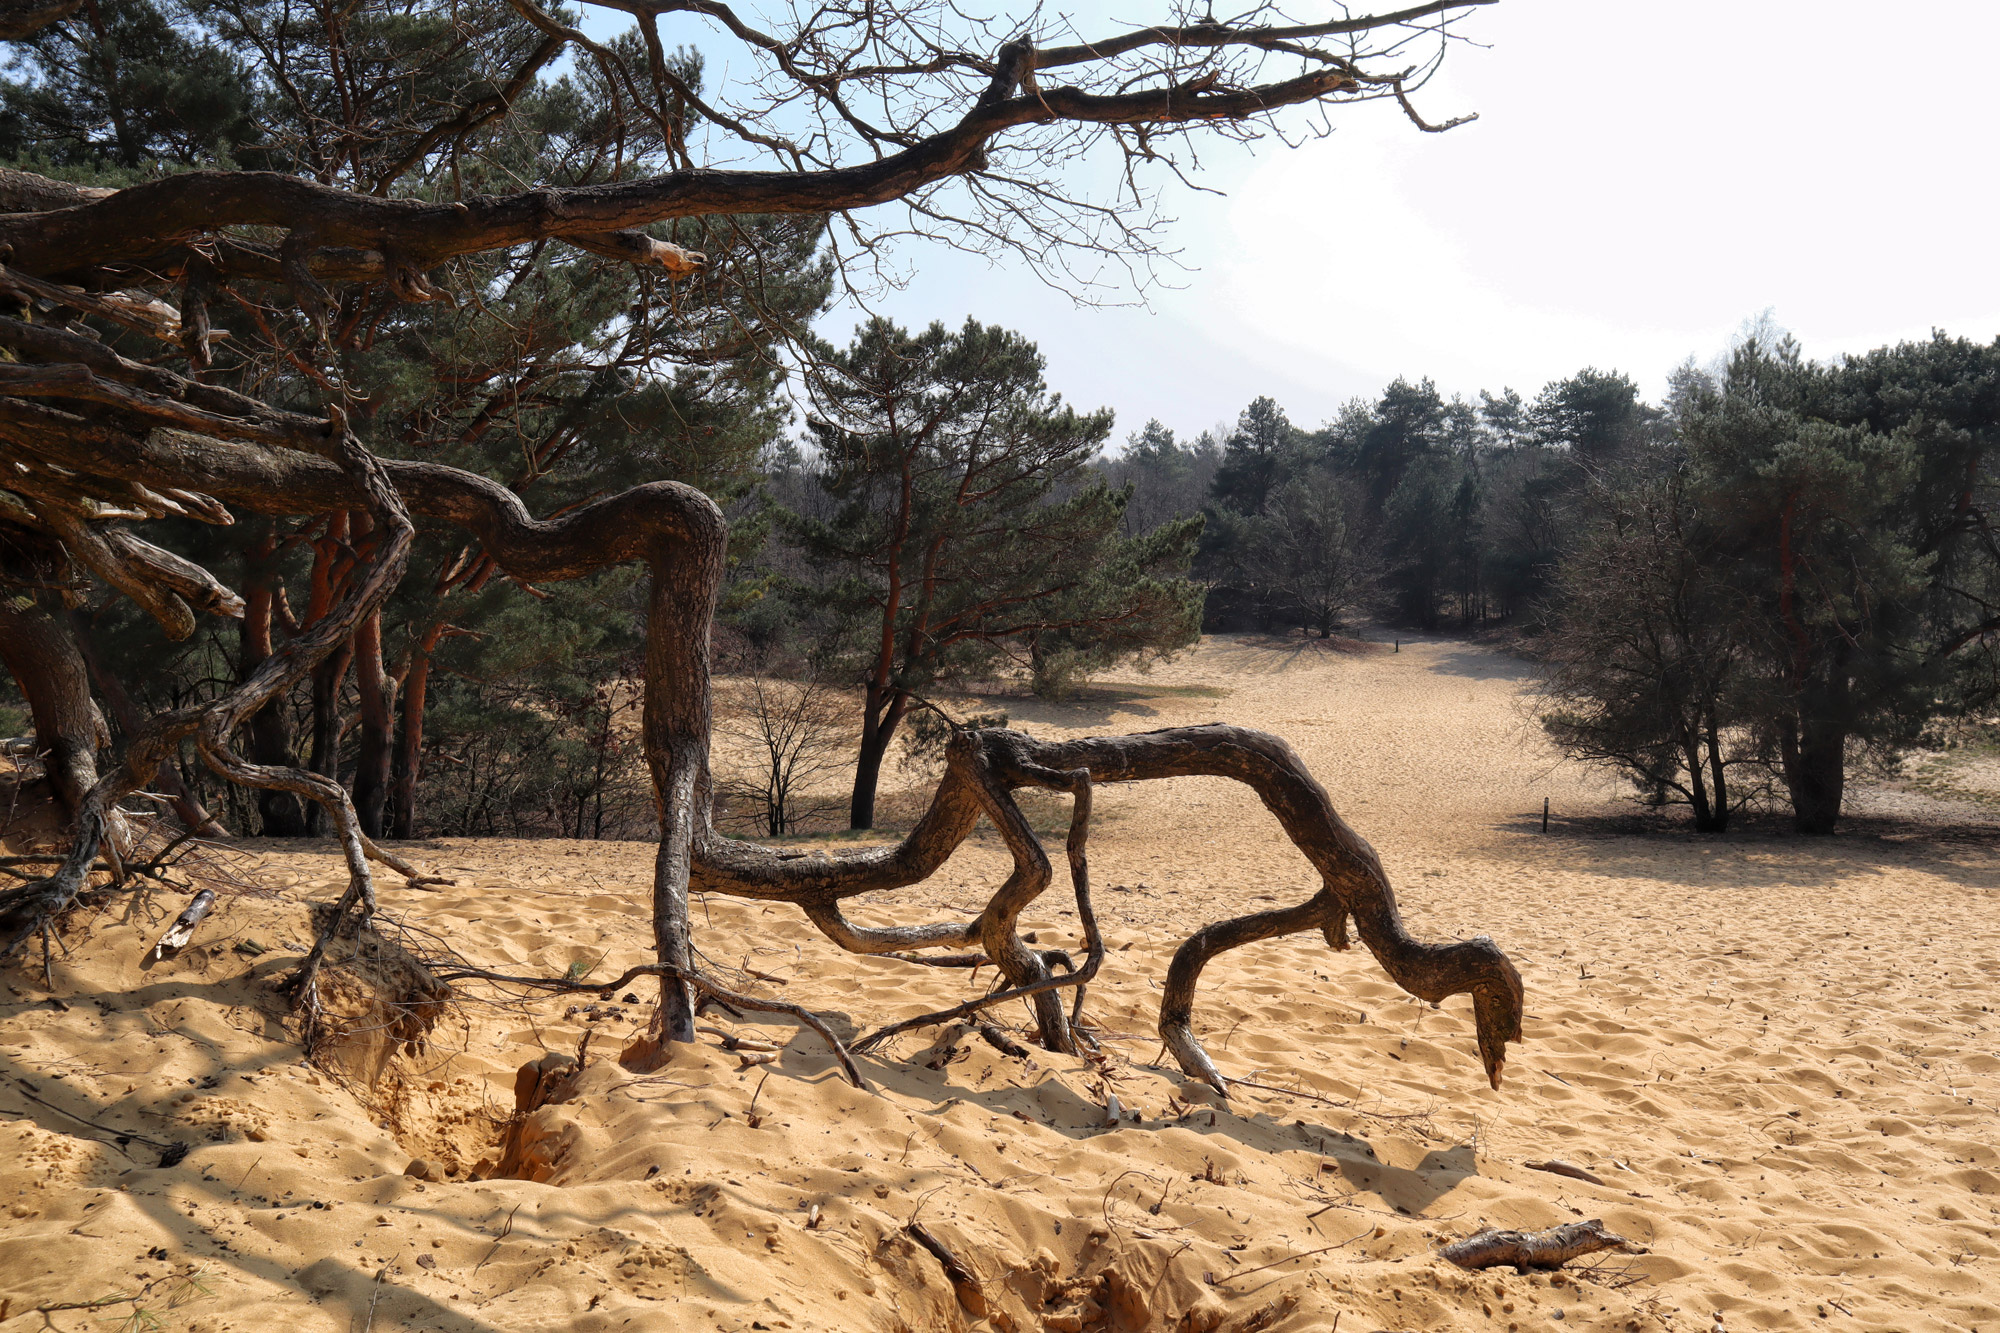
<box><xmin>788</xmin><ymin>318</ymin><xmax>1200</xmax><ymax>829</ymax></box>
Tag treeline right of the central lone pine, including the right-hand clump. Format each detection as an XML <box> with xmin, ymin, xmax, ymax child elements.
<box><xmin>1104</xmin><ymin>330</ymin><xmax>2000</xmax><ymax>833</ymax></box>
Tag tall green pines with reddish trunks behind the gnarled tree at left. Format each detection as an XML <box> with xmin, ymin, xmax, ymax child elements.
<box><xmin>0</xmin><ymin>0</ymin><xmax>830</xmax><ymax>837</ymax></box>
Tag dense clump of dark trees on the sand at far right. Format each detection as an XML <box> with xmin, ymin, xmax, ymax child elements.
<box><xmin>1544</xmin><ymin>334</ymin><xmax>2000</xmax><ymax>833</ymax></box>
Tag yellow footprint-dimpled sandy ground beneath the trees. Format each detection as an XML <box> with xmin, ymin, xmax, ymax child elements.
<box><xmin>0</xmin><ymin>638</ymin><xmax>2000</xmax><ymax>1333</ymax></box>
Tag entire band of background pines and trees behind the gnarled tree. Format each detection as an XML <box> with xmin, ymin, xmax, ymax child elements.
<box><xmin>0</xmin><ymin>0</ymin><xmax>2000</xmax><ymax>837</ymax></box>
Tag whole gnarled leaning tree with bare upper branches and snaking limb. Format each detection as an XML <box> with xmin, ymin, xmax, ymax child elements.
<box><xmin>0</xmin><ymin>0</ymin><xmax>1522</xmax><ymax>1091</ymax></box>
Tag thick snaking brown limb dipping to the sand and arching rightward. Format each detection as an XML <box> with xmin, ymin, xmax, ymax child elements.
<box><xmin>3</xmin><ymin>418</ymin><xmax>1522</xmax><ymax>1089</ymax></box>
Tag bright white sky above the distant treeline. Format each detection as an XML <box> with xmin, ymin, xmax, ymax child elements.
<box><xmin>596</xmin><ymin>0</ymin><xmax>2000</xmax><ymax>438</ymax></box>
